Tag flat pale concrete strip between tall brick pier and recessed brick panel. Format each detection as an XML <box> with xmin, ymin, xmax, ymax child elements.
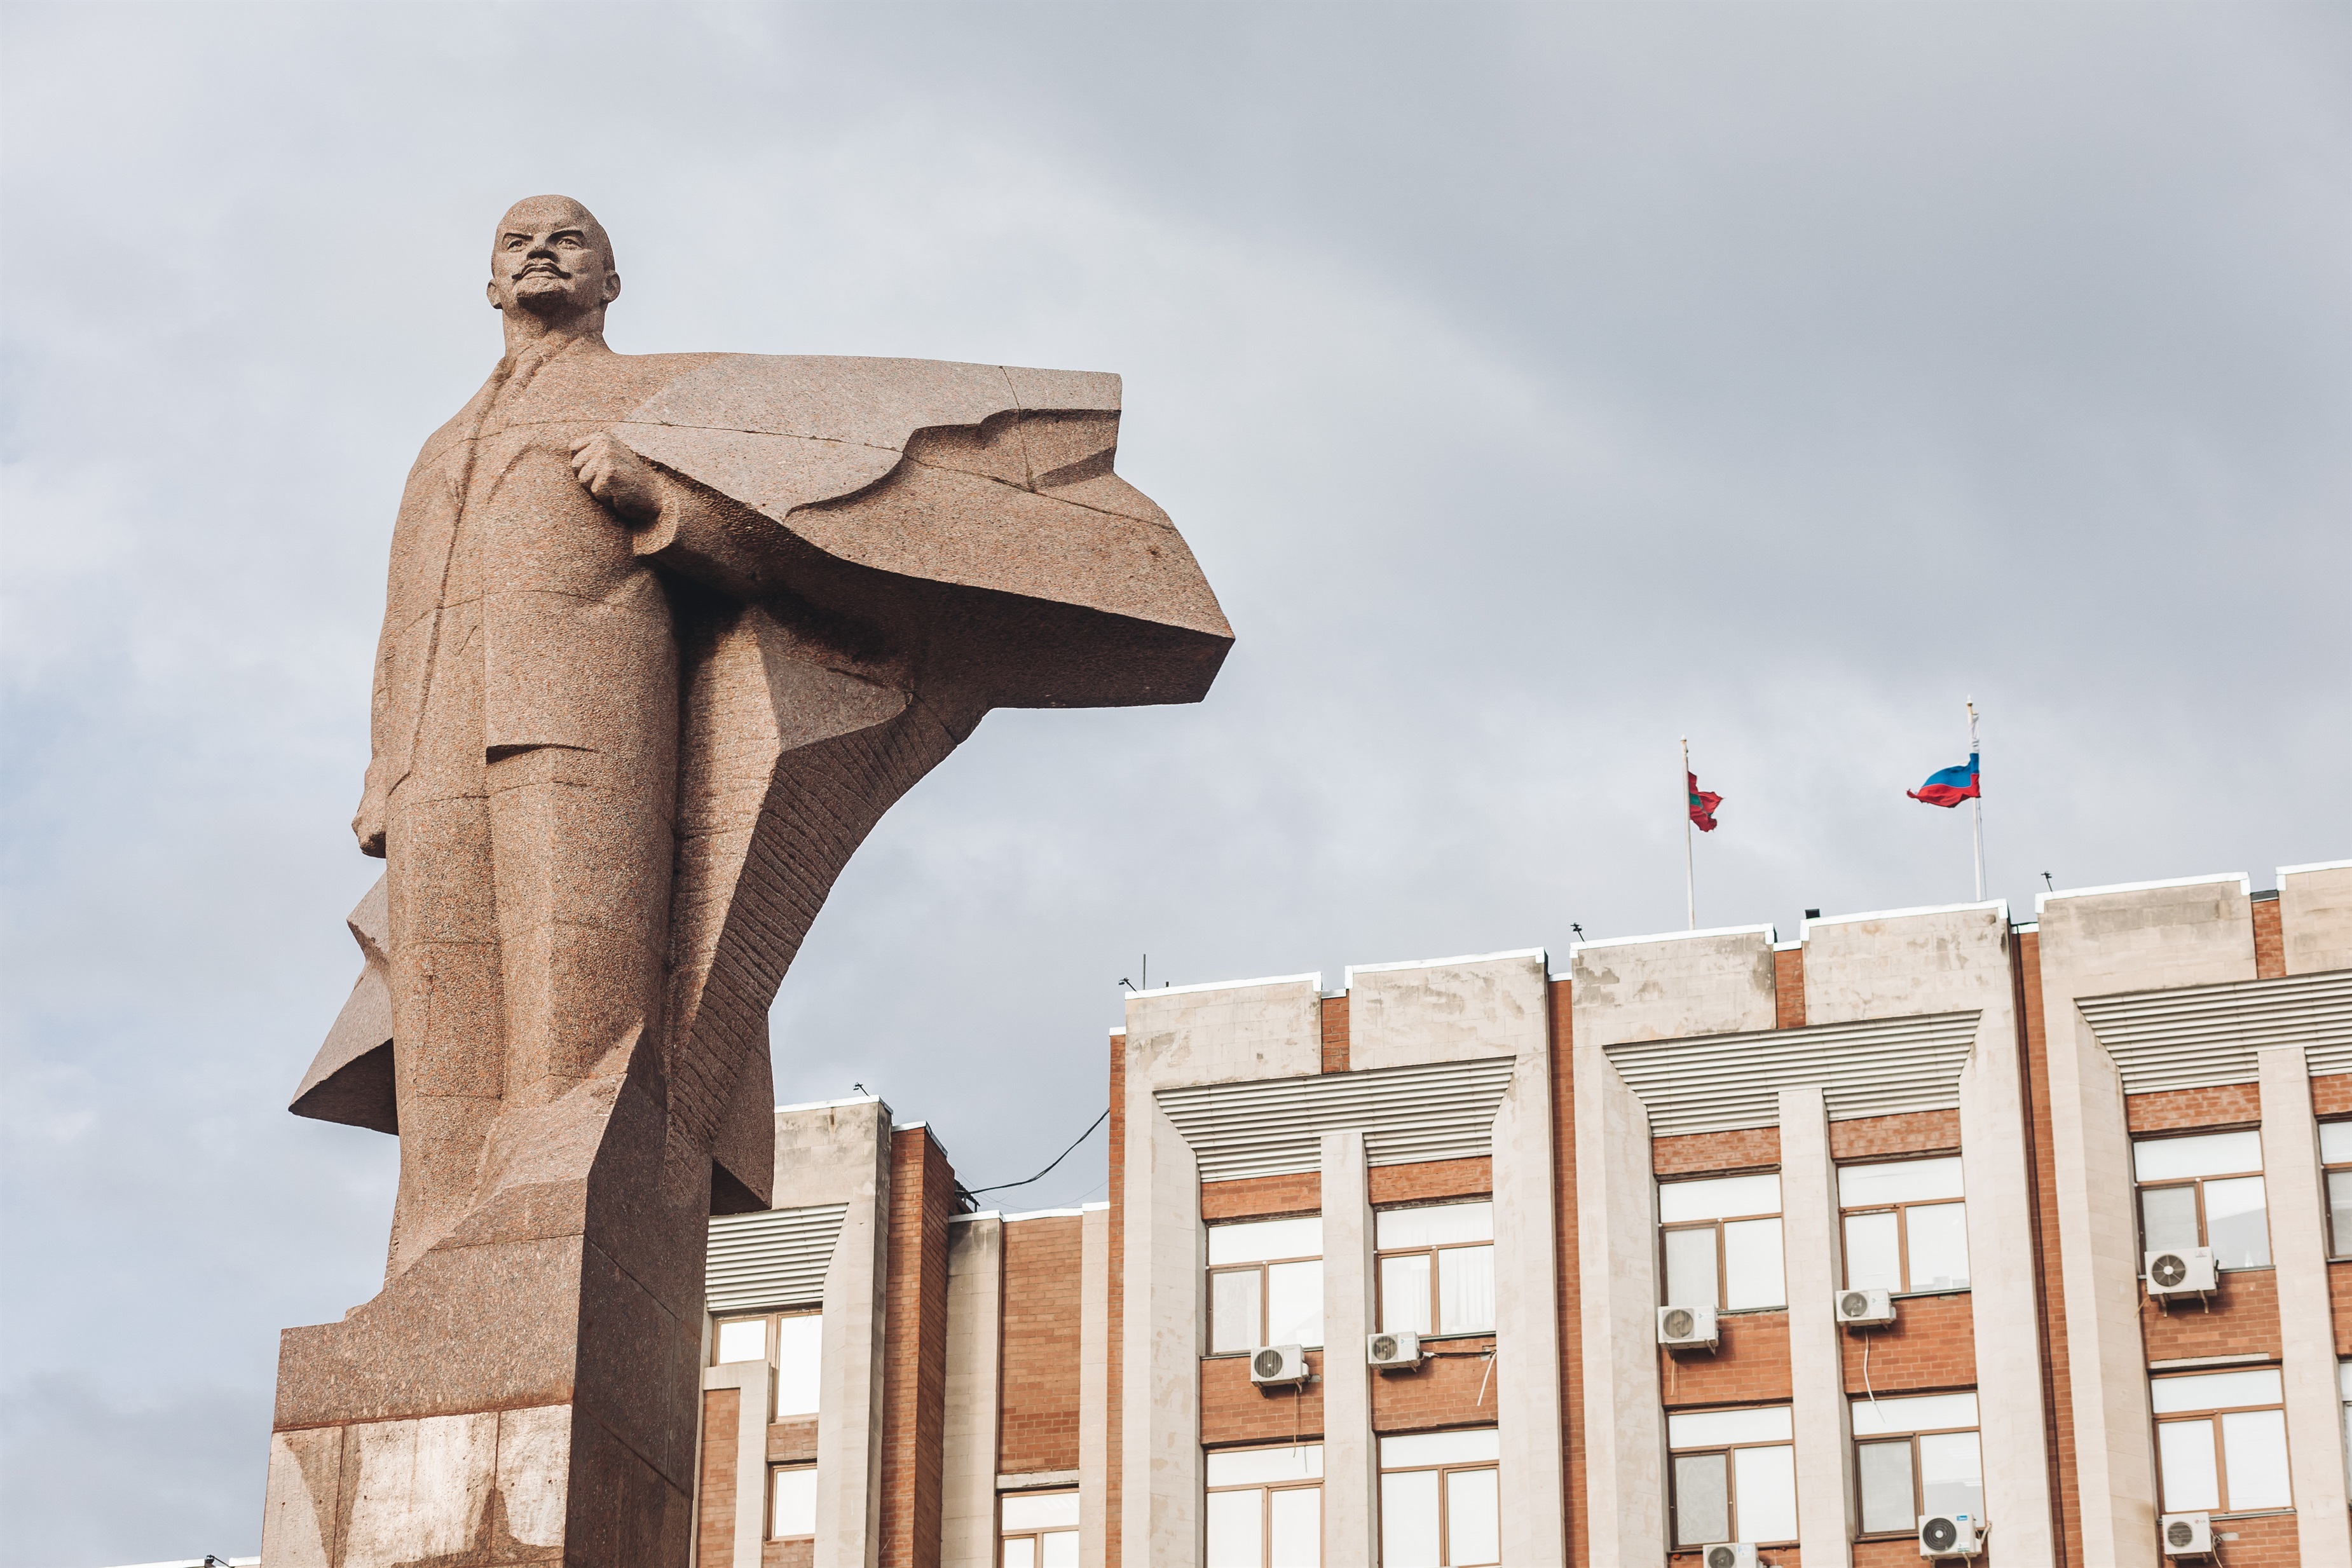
<box><xmin>938</xmin><ymin>1213</ymin><xmax>1004</xmax><ymax>1568</ymax></box>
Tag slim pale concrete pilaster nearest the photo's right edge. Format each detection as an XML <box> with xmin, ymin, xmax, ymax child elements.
<box><xmin>2255</xmin><ymin>1046</ymin><xmax>2352</xmax><ymax>1568</ymax></box>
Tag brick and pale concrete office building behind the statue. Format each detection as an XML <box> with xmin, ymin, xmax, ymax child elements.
<box><xmin>694</xmin><ymin>861</ymin><xmax>2352</xmax><ymax>1568</ymax></box>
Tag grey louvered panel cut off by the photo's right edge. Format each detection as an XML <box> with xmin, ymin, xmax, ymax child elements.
<box><xmin>2074</xmin><ymin>969</ymin><xmax>2352</xmax><ymax>1096</ymax></box>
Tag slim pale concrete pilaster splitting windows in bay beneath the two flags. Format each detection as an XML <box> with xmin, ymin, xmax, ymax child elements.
<box><xmin>1781</xmin><ymin>1088</ymin><xmax>1854</xmax><ymax>1568</ymax></box>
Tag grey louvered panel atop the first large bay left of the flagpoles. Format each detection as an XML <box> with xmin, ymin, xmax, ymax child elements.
<box><xmin>1155</xmin><ymin>1056</ymin><xmax>1517</xmax><ymax>1182</ymax></box>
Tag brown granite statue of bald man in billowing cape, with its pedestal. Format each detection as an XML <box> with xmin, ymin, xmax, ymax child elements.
<box><xmin>263</xmin><ymin>198</ymin><xmax>1233</xmax><ymax>1568</ymax></box>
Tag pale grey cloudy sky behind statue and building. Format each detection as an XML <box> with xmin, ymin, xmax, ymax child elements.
<box><xmin>0</xmin><ymin>4</ymin><xmax>2352</xmax><ymax>1568</ymax></box>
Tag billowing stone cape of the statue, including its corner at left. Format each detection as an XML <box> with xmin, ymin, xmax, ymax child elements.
<box><xmin>292</xmin><ymin>355</ymin><xmax>1233</xmax><ymax>1211</ymax></box>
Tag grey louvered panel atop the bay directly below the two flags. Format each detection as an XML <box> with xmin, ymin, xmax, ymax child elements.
<box><xmin>1604</xmin><ymin>1013</ymin><xmax>1978</xmax><ymax>1138</ymax></box>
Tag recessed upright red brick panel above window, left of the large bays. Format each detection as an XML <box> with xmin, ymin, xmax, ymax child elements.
<box><xmin>997</xmin><ymin>1213</ymin><xmax>1084</xmax><ymax>1476</ymax></box>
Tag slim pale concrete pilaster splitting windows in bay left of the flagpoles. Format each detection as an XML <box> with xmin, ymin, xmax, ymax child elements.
<box><xmin>1322</xmin><ymin>1133</ymin><xmax>1381</xmax><ymax>1568</ymax></box>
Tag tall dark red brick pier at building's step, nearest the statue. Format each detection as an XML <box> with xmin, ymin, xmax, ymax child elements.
<box><xmin>880</xmin><ymin>1126</ymin><xmax>955</xmax><ymax>1568</ymax></box>
